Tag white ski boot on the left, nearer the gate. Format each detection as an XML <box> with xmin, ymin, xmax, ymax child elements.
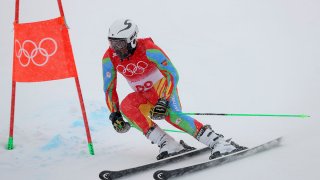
<box><xmin>146</xmin><ymin>126</ymin><xmax>195</xmax><ymax>160</ymax></box>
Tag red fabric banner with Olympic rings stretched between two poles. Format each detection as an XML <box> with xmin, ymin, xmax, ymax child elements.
<box><xmin>13</xmin><ymin>17</ymin><xmax>78</xmax><ymax>82</ymax></box>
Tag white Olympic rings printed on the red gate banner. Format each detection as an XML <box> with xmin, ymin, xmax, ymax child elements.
<box><xmin>15</xmin><ymin>37</ymin><xmax>58</xmax><ymax>67</ymax></box>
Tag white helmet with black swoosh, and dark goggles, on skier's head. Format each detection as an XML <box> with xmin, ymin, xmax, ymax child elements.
<box><xmin>108</xmin><ymin>19</ymin><xmax>139</xmax><ymax>59</ymax></box>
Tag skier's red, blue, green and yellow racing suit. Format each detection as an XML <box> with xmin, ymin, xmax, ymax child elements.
<box><xmin>102</xmin><ymin>38</ymin><xmax>203</xmax><ymax>137</ymax></box>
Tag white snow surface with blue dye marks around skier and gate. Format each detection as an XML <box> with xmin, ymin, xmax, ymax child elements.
<box><xmin>0</xmin><ymin>0</ymin><xmax>320</xmax><ymax>180</ymax></box>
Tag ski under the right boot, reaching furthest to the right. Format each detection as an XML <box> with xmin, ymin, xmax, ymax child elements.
<box><xmin>153</xmin><ymin>137</ymin><xmax>282</xmax><ymax>180</ymax></box>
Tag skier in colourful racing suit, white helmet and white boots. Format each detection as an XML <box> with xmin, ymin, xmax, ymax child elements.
<box><xmin>102</xmin><ymin>19</ymin><xmax>244</xmax><ymax>160</ymax></box>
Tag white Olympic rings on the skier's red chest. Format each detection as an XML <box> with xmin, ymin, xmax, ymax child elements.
<box><xmin>117</xmin><ymin>61</ymin><xmax>148</xmax><ymax>76</ymax></box>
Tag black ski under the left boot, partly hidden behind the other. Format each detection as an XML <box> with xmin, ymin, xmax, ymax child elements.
<box><xmin>99</xmin><ymin>147</ymin><xmax>211</xmax><ymax>180</ymax></box>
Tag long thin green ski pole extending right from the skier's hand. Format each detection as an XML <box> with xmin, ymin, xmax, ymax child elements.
<box><xmin>170</xmin><ymin>112</ymin><xmax>310</xmax><ymax>118</ymax></box>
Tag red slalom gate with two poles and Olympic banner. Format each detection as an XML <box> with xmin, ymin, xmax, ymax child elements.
<box><xmin>7</xmin><ymin>0</ymin><xmax>94</xmax><ymax>155</ymax></box>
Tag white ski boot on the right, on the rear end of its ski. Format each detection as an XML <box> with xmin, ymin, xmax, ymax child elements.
<box><xmin>196</xmin><ymin>125</ymin><xmax>246</xmax><ymax>159</ymax></box>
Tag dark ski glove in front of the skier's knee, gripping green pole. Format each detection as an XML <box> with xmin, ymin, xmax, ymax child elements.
<box><xmin>150</xmin><ymin>98</ymin><xmax>169</xmax><ymax>120</ymax></box>
